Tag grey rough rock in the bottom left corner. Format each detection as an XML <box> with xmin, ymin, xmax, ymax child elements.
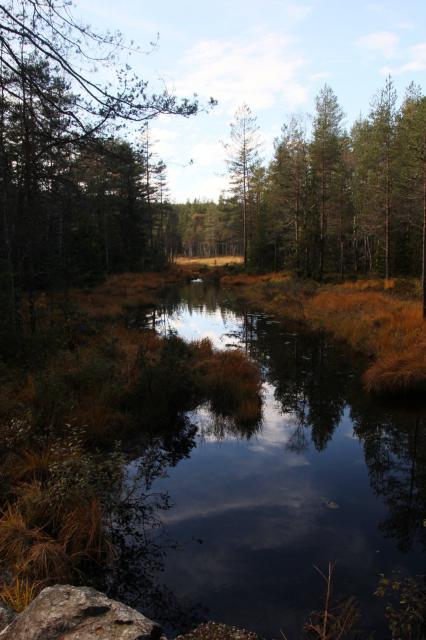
<box><xmin>0</xmin><ymin>585</ymin><xmax>164</xmax><ymax>640</ymax></box>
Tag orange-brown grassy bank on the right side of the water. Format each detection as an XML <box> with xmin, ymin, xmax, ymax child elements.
<box><xmin>221</xmin><ymin>273</ymin><xmax>426</xmax><ymax>394</ymax></box>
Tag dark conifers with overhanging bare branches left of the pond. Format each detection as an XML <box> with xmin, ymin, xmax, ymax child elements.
<box><xmin>0</xmin><ymin>0</ymin><xmax>206</xmax><ymax>356</ymax></box>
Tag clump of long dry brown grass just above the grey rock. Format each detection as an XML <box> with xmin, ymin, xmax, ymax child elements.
<box><xmin>0</xmin><ymin>456</ymin><xmax>113</xmax><ymax>584</ymax></box>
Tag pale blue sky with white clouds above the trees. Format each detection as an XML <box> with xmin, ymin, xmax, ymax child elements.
<box><xmin>75</xmin><ymin>0</ymin><xmax>426</xmax><ymax>202</ymax></box>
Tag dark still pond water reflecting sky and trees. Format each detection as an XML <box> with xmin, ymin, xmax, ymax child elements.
<box><xmin>128</xmin><ymin>283</ymin><xmax>426</xmax><ymax>640</ymax></box>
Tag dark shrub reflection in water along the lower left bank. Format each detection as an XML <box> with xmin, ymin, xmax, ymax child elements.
<box><xmin>104</xmin><ymin>419</ymin><xmax>204</xmax><ymax>630</ymax></box>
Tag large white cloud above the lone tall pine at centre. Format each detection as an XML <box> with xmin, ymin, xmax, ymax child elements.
<box><xmin>176</xmin><ymin>29</ymin><xmax>308</xmax><ymax>113</ymax></box>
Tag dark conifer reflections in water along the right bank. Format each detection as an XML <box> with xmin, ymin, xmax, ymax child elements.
<box><xmin>228</xmin><ymin>298</ymin><xmax>426</xmax><ymax>551</ymax></box>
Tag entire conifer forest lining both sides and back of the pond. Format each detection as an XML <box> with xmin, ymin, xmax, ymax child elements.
<box><xmin>0</xmin><ymin>2</ymin><xmax>426</xmax><ymax>344</ymax></box>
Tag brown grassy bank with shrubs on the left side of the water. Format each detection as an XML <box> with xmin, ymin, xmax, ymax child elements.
<box><xmin>0</xmin><ymin>269</ymin><xmax>261</xmax><ymax>610</ymax></box>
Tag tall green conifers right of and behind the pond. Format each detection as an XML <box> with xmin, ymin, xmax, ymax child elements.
<box><xmin>175</xmin><ymin>78</ymin><xmax>426</xmax><ymax>279</ymax></box>
